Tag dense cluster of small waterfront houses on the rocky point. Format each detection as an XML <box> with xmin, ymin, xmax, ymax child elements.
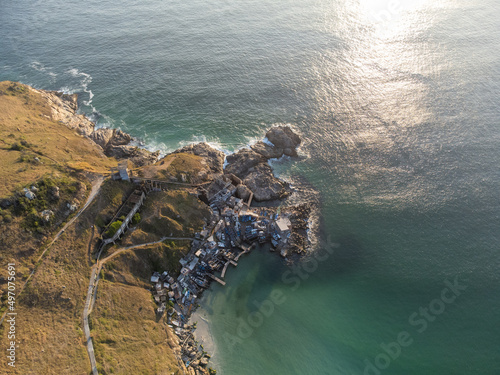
<box><xmin>151</xmin><ymin>178</ymin><xmax>292</xmax><ymax>370</ymax></box>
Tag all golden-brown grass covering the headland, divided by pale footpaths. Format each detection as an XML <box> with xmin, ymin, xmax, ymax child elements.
<box><xmin>0</xmin><ymin>82</ymin><xmax>208</xmax><ymax>375</ymax></box>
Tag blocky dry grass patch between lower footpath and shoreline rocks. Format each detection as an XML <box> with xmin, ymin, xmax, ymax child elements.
<box><xmin>91</xmin><ymin>280</ymin><xmax>179</xmax><ymax>375</ymax></box>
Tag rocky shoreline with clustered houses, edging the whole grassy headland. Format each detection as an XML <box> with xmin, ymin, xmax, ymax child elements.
<box><xmin>32</xmin><ymin>89</ymin><xmax>313</xmax><ymax>375</ymax></box>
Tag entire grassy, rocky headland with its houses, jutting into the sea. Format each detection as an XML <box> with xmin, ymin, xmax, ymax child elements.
<box><xmin>0</xmin><ymin>82</ymin><xmax>311</xmax><ymax>375</ymax></box>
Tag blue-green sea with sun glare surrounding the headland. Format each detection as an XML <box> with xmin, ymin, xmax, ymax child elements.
<box><xmin>0</xmin><ymin>0</ymin><xmax>500</xmax><ymax>375</ymax></box>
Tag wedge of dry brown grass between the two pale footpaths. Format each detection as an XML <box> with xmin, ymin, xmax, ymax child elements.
<box><xmin>7</xmin><ymin>197</ymin><xmax>93</xmax><ymax>374</ymax></box>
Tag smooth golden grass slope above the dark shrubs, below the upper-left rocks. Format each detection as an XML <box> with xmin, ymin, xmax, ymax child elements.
<box><xmin>0</xmin><ymin>81</ymin><xmax>116</xmax><ymax>197</ymax></box>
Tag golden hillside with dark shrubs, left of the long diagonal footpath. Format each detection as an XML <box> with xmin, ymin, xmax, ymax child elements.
<box><xmin>0</xmin><ymin>82</ymin><xmax>116</xmax><ymax>294</ymax></box>
